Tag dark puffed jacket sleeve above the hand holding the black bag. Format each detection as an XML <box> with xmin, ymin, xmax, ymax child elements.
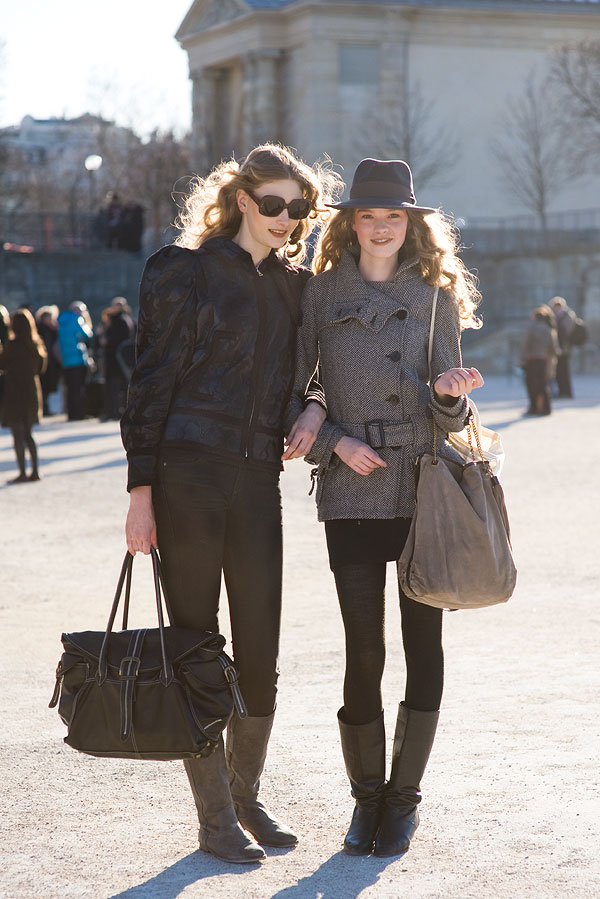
<box><xmin>121</xmin><ymin>246</ymin><xmax>197</xmax><ymax>490</ymax></box>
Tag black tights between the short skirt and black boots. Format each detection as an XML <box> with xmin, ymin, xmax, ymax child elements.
<box><xmin>334</xmin><ymin>562</ymin><xmax>444</xmax><ymax>724</ymax></box>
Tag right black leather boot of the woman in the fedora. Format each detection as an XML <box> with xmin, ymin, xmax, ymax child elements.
<box><xmin>375</xmin><ymin>703</ymin><xmax>440</xmax><ymax>858</ymax></box>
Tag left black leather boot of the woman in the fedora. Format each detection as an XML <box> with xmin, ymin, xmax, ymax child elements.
<box><xmin>338</xmin><ymin>708</ymin><xmax>385</xmax><ymax>855</ymax></box>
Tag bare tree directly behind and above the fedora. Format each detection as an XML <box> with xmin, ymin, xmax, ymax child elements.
<box><xmin>368</xmin><ymin>80</ymin><xmax>461</xmax><ymax>190</ymax></box>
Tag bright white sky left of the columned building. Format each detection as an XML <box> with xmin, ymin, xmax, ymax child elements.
<box><xmin>0</xmin><ymin>0</ymin><xmax>192</xmax><ymax>133</ymax></box>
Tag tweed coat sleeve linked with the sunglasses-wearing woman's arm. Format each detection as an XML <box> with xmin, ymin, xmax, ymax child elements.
<box><xmin>285</xmin><ymin>278</ymin><xmax>345</xmax><ymax>467</ymax></box>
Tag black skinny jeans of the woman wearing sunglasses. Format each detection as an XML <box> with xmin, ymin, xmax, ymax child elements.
<box><xmin>153</xmin><ymin>455</ymin><xmax>282</xmax><ymax>716</ymax></box>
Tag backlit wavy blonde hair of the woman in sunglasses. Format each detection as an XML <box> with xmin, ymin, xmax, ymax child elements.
<box><xmin>175</xmin><ymin>144</ymin><xmax>344</xmax><ymax>263</ymax></box>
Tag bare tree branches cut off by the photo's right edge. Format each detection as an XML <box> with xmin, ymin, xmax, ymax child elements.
<box><xmin>551</xmin><ymin>39</ymin><xmax>600</xmax><ymax>172</ymax></box>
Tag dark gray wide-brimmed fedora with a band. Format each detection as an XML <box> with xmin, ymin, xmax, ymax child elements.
<box><xmin>327</xmin><ymin>159</ymin><xmax>437</xmax><ymax>212</ymax></box>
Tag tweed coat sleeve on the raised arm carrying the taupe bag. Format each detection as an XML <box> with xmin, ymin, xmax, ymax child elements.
<box><xmin>429</xmin><ymin>290</ymin><xmax>469</xmax><ymax>433</ymax></box>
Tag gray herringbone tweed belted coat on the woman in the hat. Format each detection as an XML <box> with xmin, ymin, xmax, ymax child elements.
<box><xmin>286</xmin><ymin>250</ymin><xmax>468</xmax><ymax>521</ymax></box>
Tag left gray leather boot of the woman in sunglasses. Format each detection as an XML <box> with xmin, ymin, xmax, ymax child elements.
<box><xmin>183</xmin><ymin>737</ymin><xmax>266</xmax><ymax>865</ymax></box>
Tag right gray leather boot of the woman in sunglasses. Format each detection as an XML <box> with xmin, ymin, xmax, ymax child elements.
<box><xmin>227</xmin><ymin>712</ymin><xmax>298</xmax><ymax>849</ymax></box>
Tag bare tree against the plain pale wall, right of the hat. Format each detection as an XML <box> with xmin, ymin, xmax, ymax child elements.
<box><xmin>491</xmin><ymin>74</ymin><xmax>568</xmax><ymax>229</ymax></box>
